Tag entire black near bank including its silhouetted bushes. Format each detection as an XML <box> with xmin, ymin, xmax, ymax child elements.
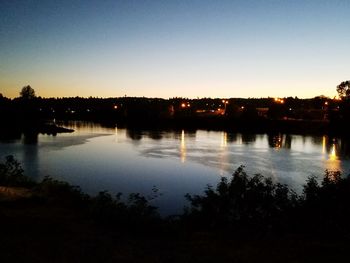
<box><xmin>0</xmin><ymin>157</ymin><xmax>350</xmax><ymax>262</ymax></box>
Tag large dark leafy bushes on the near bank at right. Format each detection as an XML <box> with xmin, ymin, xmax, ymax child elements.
<box><xmin>183</xmin><ymin>166</ymin><xmax>350</xmax><ymax>237</ymax></box>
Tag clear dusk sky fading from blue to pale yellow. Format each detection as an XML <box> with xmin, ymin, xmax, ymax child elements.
<box><xmin>0</xmin><ymin>0</ymin><xmax>350</xmax><ymax>98</ymax></box>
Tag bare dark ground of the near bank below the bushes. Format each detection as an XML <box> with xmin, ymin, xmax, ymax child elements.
<box><xmin>0</xmin><ymin>187</ymin><xmax>349</xmax><ymax>263</ymax></box>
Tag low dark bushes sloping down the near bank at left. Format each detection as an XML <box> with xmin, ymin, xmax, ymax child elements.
<box><xmin>0</xmin><ymin>156</ymin><xmax>160</xmax><ymax>230</ymax></box>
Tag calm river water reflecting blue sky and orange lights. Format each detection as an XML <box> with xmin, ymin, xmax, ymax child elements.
<box><xmin>0</xmin><ymin>122</ymin><xmax>350</xmax><ymax>215</ymax></box>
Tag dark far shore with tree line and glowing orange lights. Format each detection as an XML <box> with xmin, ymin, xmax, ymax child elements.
<box><xmin>0</xmin><ymin>81</ymin><xmax>350</xmax><ymax>133</ymax></box>
